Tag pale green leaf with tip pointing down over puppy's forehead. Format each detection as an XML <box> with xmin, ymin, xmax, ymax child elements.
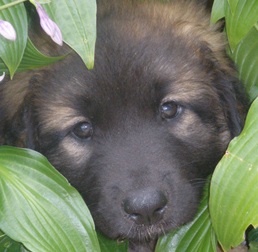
<box><xmin>44</xmin><ymin>0</ymin><xmax>96</xmax><ymax>69</ymax></box>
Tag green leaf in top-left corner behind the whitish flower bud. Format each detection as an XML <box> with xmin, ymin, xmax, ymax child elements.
<box><xmin>0</xmin><ymin>0</ymin><xmax>28</xmax><ymax>77</ymax></box>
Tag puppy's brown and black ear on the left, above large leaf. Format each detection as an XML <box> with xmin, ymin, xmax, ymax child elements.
<box><xmin>0</xmin><ymin>72</ymin><xmax>39</xmax><ymax>149</ymax></box>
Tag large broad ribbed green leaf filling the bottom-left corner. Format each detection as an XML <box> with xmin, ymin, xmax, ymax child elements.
<box><xmin>0</xmin><ymin>146</ymin><xmax>100</xmax><ymax>252</ymax></box>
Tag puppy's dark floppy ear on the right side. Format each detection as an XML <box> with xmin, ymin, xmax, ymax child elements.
<box><xmin>203</xmin><ymin>44</ymin><xmax>249</xmax><ymax>138</ymax></box>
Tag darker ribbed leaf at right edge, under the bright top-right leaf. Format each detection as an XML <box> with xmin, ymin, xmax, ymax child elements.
<box><xmin>230</xmin><ymin>28</ymin><xmax>258</xmax><ymax>100</ymax></box>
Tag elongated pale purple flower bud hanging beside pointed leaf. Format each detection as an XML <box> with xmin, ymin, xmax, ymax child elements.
<box><xmin>35</xmin><ymin>1</ymin><xmax>63</xmax><ymax>45</ymax></box>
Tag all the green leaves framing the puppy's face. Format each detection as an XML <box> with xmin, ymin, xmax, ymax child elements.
<box><xmin>0</xmin><ymin>0</ymin><xmax>258</xmax><ymax>252</ymax></box>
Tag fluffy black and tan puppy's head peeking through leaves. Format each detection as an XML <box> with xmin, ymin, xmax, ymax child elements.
<box><xmin>1</xmin><ymin>0</ymin><xmax>247</xmax><ymax>251</ymax></box>
